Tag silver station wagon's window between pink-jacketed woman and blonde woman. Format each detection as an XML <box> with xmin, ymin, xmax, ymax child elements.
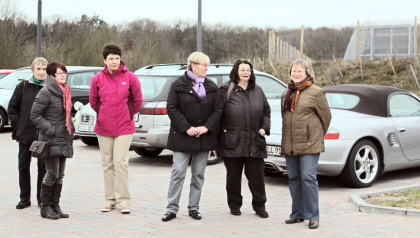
<box><xmin>137</xmin><ymin>75</ymin><xmax>175</xmax><ymax>101</ymax></box>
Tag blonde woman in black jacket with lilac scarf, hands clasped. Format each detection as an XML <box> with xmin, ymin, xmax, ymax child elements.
<box><xmin>162</xmin><ymin>52</ymin><xmax>222</xmax><ymax>221</ymax></box>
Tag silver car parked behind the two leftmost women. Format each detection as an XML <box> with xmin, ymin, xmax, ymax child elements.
<box><xmin>0</xmin><ymin>66</ymin><xmax>102</xmax><ymax>131</ymax></box>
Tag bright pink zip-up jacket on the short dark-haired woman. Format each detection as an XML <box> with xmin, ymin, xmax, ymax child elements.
<box><xmin>89</xmin><ymin>62</ymin><xmax>143</xmax><ymax>137</ymax></box>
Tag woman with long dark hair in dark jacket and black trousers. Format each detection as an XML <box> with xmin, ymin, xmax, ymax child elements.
<box><xmin>217</xmin><ymin>60</ymin><xmax>270</xmax><ymax>218</ymax></box>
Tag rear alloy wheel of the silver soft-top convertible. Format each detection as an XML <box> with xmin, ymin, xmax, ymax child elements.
<box><xmin>339</xmin><ymin>140</ymin><xmax>381</xmax><ymax>188</ymax></box>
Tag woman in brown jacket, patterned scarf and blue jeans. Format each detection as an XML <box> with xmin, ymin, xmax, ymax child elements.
<box><xmin>281</xmin><ymin>59</ymin><xmax>331</xmax><ymax>229</ymax></box>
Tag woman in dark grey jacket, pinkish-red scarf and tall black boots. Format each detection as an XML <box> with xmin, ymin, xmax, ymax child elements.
<box><xmin>31</xmin><ymin>61</ymin><xmax>74</xmax><ymax>219</ymax></box>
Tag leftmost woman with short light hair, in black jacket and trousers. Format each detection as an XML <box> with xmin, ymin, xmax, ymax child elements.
<box><xmin>7</xmin><ymin>57</ymin><xmax>48</xmax><ymax>209</ymax></box>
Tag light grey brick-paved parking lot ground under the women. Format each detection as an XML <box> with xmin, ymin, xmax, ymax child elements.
<box><xmin>0</xmin><ymin>128</ymin><xmax>420</xmax><ymax>237</ymax></box>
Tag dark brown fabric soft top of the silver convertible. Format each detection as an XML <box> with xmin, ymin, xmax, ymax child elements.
<box><xmin>322</xmin><ymin>84</ymin><xmax>410</xmax><ymax>117</ymax></box>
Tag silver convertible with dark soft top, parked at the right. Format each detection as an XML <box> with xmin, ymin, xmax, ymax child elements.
<box><xmin>265</xmin><ymin>84</ymin><xmax>420</xmax><ymax>188</ymax></box>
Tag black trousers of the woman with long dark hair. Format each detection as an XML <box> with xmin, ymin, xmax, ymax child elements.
<box><xmin>223</xmin><ymin>157</ymin><xmax>267</xmax><ymax>211</ymax></box>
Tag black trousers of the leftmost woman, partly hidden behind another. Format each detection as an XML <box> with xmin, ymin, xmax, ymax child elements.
<box><xmin>18</xmin><ymin>142</ymin><xmax>45</xmax><ymax>201</ymax></box>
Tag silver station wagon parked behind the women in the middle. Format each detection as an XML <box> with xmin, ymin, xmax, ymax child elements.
<box><xmin>75</xmin><ymin>64</ymin><xmax>287</xmax><ymax>164</ymax></box>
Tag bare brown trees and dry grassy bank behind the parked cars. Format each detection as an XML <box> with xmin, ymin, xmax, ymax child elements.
<box><xmin>0</xmin><ymin>0</ymin><xmax>420</xmax><ymax>94</ymax></box>
